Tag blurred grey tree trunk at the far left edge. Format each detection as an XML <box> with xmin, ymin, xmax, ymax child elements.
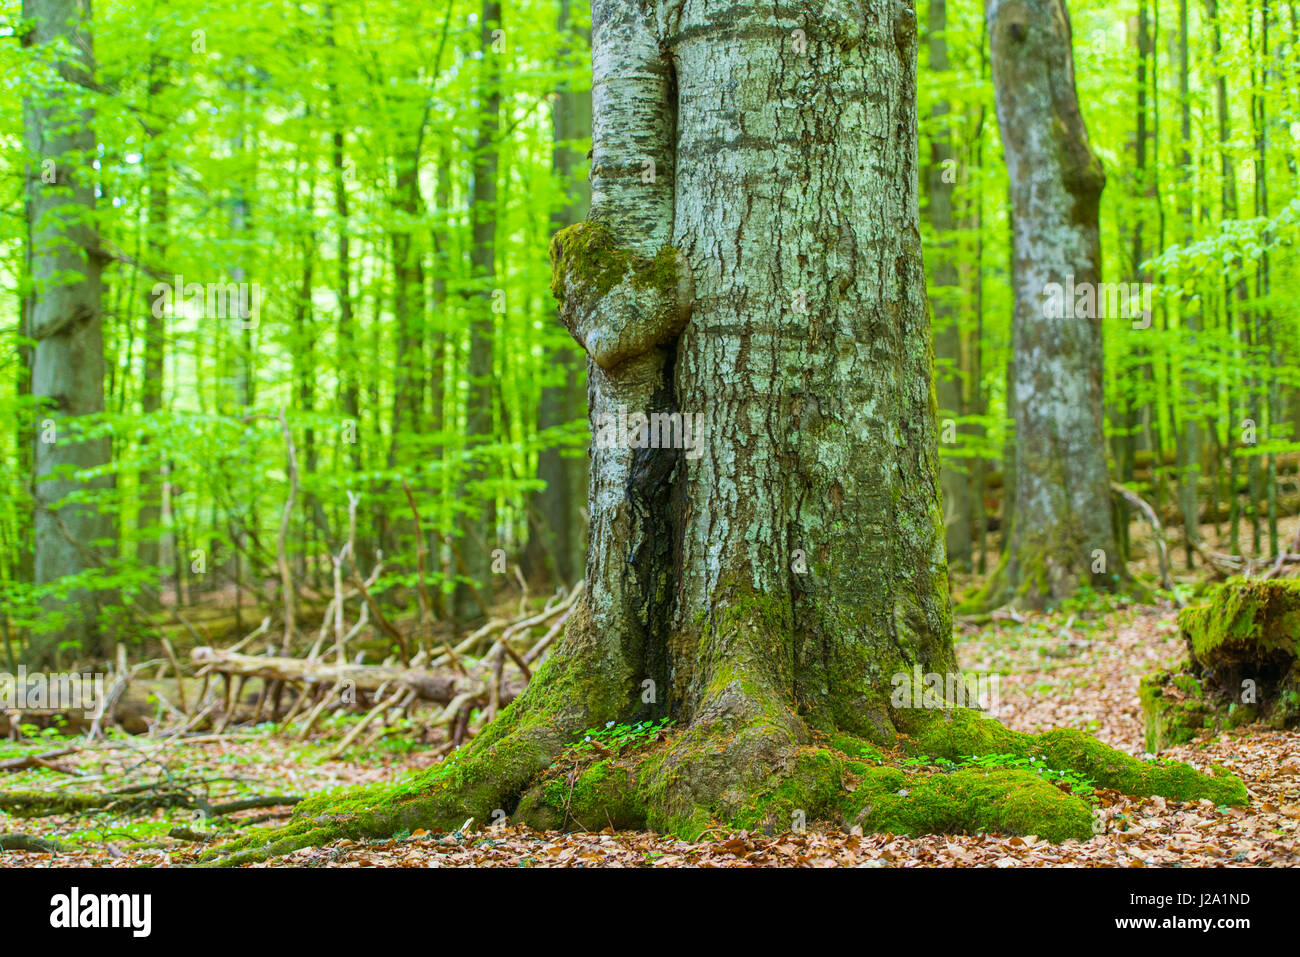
<box><xmin>22</xmin><ymin>0</ymin><xmax>116</xmax><ymax>663</ymax></box>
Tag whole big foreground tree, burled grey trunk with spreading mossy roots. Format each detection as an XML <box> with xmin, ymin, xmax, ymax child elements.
<box><xmin>202</xmin><ymin>0</ymin><xmax>1245</xmax><ymax>862</ymax></box>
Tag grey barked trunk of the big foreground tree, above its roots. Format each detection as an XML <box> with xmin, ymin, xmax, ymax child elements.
<box><xmin>553</xmin><ymin>0</ymin><xmax>953</xmax><ymax>748</ymax></box>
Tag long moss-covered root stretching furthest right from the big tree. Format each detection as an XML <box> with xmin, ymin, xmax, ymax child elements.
<box><xmin>909</xmin><ymin>709</ymin><xmax>1249</xmax><ymax>805</ymax></box>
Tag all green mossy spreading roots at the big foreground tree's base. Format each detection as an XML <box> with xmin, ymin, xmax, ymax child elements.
<box><xmin>204</xmin><ymin>676</ymin><xmax>1248</xmax><ymax>865</ymax></box>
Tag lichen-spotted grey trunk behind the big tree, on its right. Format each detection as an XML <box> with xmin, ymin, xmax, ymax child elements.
<box><xmin>988</xmin><ymin>0</ymin><xmax>1123</xmax><ymax>607</ymax></box>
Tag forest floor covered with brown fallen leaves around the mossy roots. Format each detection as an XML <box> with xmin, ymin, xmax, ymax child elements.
<box><xmin>0</xmin><ymin>590</ymin><xmax>1300</xmax><ymax>867</ymax></box>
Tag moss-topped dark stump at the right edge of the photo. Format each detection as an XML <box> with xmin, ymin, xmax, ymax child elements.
<box><xmin>1140</xmin><ymin>579</ymin><xmax>1300</xmax><ymax>753</ymax></box>
